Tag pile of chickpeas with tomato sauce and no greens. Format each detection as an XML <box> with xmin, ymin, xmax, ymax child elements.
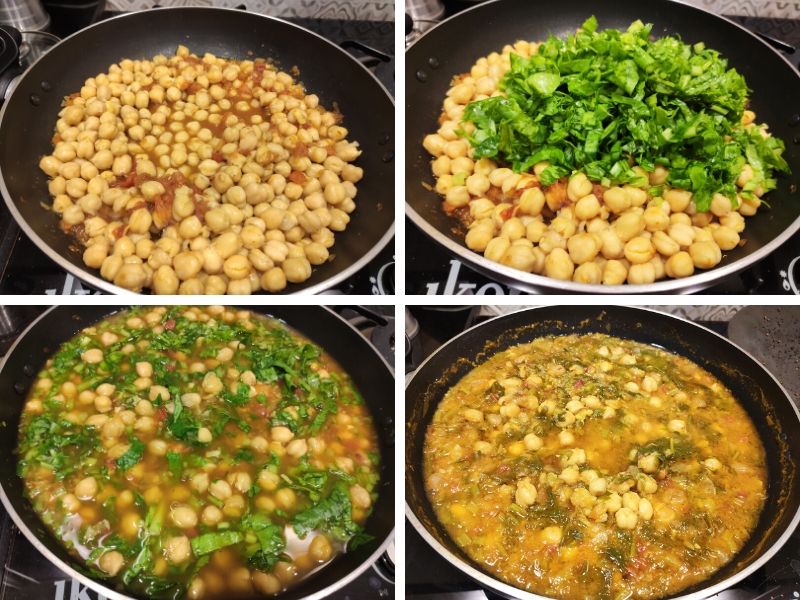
<box><xmin>39</xmin><ymin>46</ymin><xmax>363</xmax><ymax>294</ymax></box>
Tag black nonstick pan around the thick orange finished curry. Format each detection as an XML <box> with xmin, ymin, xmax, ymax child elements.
<box><xmin>405</xmin><ymin>306</ymin><xmax>800</xmax><ymax>600</ymax></box>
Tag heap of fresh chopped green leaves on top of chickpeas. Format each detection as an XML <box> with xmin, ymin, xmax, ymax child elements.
<box><xmin>463</xmin><ymin>17</ymin><xmax>789</xmax><ymax>211</ymax></box>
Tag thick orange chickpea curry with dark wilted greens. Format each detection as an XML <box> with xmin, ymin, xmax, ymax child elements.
<box><xmin>424</xmin><ymin>334</ymin><xmax>766</xmax><ymax>599</ymax></box>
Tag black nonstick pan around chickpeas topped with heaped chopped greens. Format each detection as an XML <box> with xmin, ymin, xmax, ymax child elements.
<box><xmin>406</xmin><ymin>0</ymin><xmax>800</xmax><ymax>294</ymax></box>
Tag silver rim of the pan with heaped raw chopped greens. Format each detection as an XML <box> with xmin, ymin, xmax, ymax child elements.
<box><xmin>406</xmin><ymin>0</ymin><xmax>800</xmax><ymax>295</ymax></box>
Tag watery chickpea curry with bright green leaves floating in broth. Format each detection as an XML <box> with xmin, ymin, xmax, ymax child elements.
<box><xmin>19</xmin><ymin>307</ymin><xmax>379</xmax><ymax>599</ymax></box>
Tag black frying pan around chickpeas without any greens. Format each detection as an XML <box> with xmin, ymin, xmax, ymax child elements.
<box><xmin>0</xmin><ymin>8</ymin><xmax>394</xmax><ymax>293</ymax></box>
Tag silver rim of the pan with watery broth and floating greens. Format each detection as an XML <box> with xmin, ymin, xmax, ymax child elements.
<box><xmin>0</xmin><ymin>304</ymin><xmax>395</xmax><ymax>600</ymax></box>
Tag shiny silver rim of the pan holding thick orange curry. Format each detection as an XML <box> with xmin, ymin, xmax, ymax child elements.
<box><xmin>404</xmin><ymin>303</ymin><xmax>800</xmax><ymax>600</ymax></box>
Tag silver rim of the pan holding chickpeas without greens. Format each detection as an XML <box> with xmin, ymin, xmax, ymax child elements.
<box><xmin>0</xmin><ymin>6</ymin><xmax>397</xmax><ymax>296</ymax></box>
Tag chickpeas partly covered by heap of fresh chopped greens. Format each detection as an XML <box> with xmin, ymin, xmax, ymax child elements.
<box><xmin>423</xmin><ymin>41</ymin><xmax>769</xmax><ymax>285</ymax></box>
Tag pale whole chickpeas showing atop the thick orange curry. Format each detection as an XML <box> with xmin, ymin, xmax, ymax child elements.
<box><xmin>462</xmin><ymin>345</ymin><xmax>722</xmax><ymax>532</ymax></box>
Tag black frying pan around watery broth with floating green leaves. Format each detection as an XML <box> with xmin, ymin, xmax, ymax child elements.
<box><xmin>0</xmin><ymin>306</ymin><xmax>394</xmax><ymax>600</ymax></box>
